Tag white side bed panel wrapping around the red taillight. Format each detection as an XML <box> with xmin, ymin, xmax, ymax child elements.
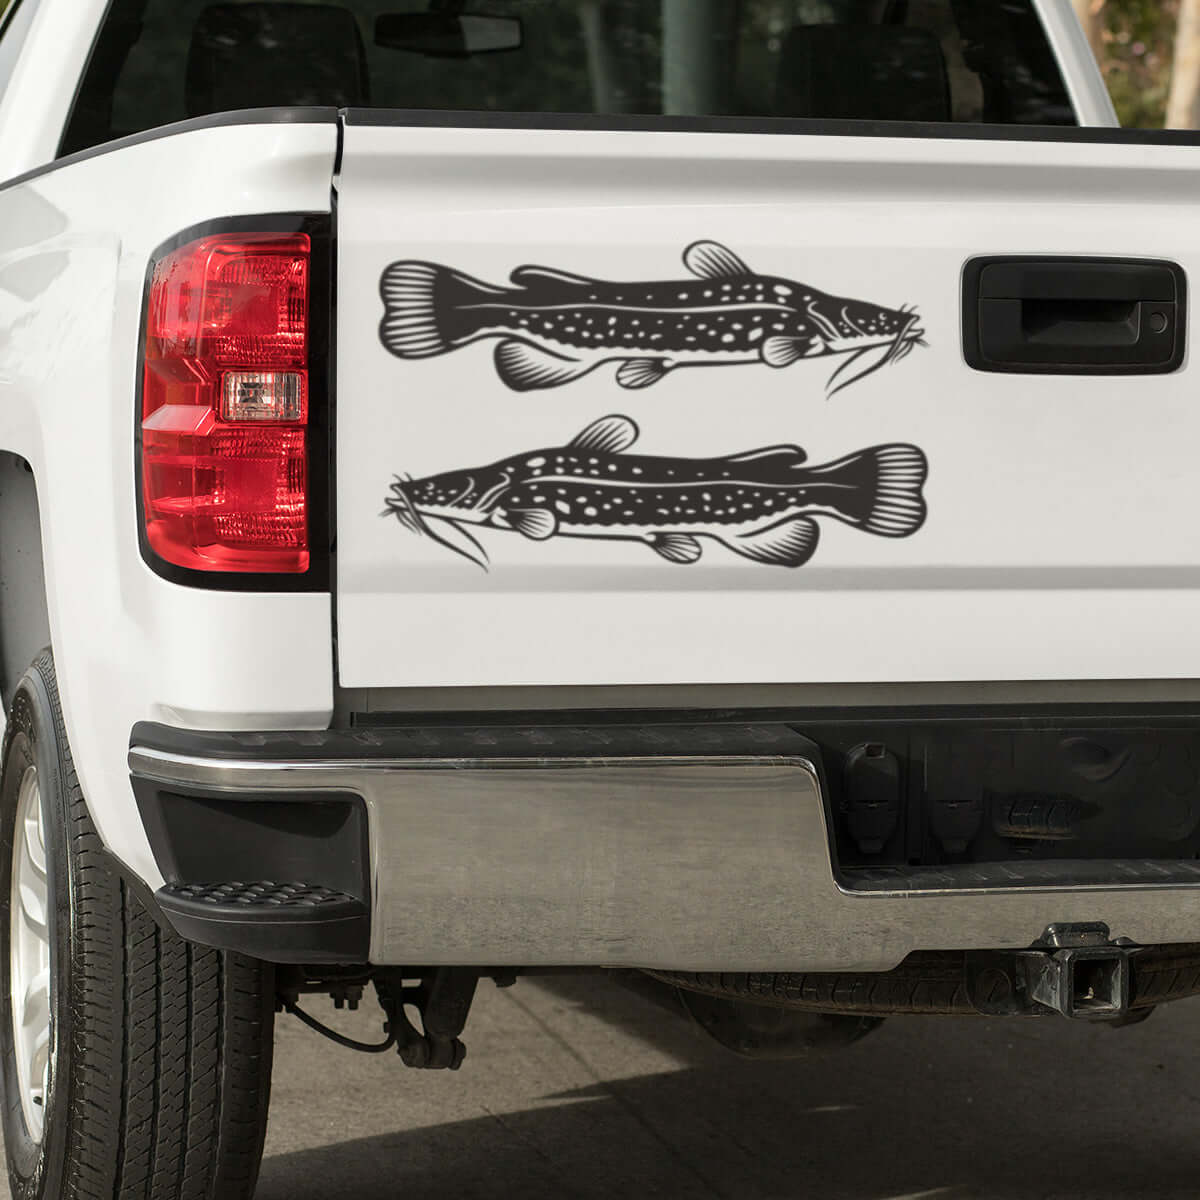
<box><xmin>0</xmin><ymin>124</ymin><xmax>337</xmax><ymax>886</ymax></box>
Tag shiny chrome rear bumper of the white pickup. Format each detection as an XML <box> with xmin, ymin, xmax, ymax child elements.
<box><xmin>130</xmin><ymin>734</ymin><xmax>1200</xmax><ymax>972</ymax></box>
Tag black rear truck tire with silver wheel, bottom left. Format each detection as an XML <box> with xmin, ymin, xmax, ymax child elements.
<box><xmin>0</xmin><ymin>650</ymin><xmax>275</xmax><ymax>1200</ymax></box>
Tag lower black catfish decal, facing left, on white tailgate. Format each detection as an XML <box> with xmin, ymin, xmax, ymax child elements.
<box><xmin>383</xmin><ymin>415</ymin><xmax>929</xmax><ymax>570</ymax></box>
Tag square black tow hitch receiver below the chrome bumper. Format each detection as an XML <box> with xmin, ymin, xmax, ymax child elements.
<box><xmin>1018</xmin><ymin>922</ymin><xmax>1139</xmax><ymax>1021</ymax></box>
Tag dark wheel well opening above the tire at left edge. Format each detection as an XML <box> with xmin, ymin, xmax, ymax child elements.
<box><xmin>0</xmin><ymin>451</ymin><xmax>50</xmax><ymax>712</ymax></box>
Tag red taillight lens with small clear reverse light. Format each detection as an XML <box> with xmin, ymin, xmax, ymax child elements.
<box><xmin>142</xmin><ymin>234</ymin><xmax>311</xmax><ymax>574</ymax></box>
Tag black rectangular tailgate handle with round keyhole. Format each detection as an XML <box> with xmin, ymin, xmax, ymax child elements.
<box><xmin>962</xmin><ymin>258</ymin><xmax>1187</xmax><ymax>374</ymax></box>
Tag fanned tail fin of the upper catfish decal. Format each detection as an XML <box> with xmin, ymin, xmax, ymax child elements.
<box><xmin>379</xmin><ymin>262</ymin><xmax>502</xmax><ymax>359</ymax></box>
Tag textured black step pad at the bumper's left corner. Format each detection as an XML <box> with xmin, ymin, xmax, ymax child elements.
<box><xmin>156</xmin><ymin>880</ymin><xmax>370</xmax><ymax>964</ymax></box>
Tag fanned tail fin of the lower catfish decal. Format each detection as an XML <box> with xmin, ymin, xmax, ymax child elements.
<box><xmin>812</xmin><ymin>443</ymin><xmax>929</xmax><ymax>538</ymax></box>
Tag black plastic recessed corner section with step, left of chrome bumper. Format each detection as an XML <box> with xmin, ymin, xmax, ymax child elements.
<box><xmin>132</xmin><ymin>758</ymin><xmax>371</xmax><ymax>964</ymax></box>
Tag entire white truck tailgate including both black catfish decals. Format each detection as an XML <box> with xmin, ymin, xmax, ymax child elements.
<box><xmin>336</xmin><ymin>113</ymin><xmax>1200</xmax><ymax>686</ymax></box>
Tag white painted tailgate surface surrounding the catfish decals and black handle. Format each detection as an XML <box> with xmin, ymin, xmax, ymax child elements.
<box><xmin>337</xmin><ymin>124</ymin><xmax>1200</xmax><ymax>688</ymax></box>
